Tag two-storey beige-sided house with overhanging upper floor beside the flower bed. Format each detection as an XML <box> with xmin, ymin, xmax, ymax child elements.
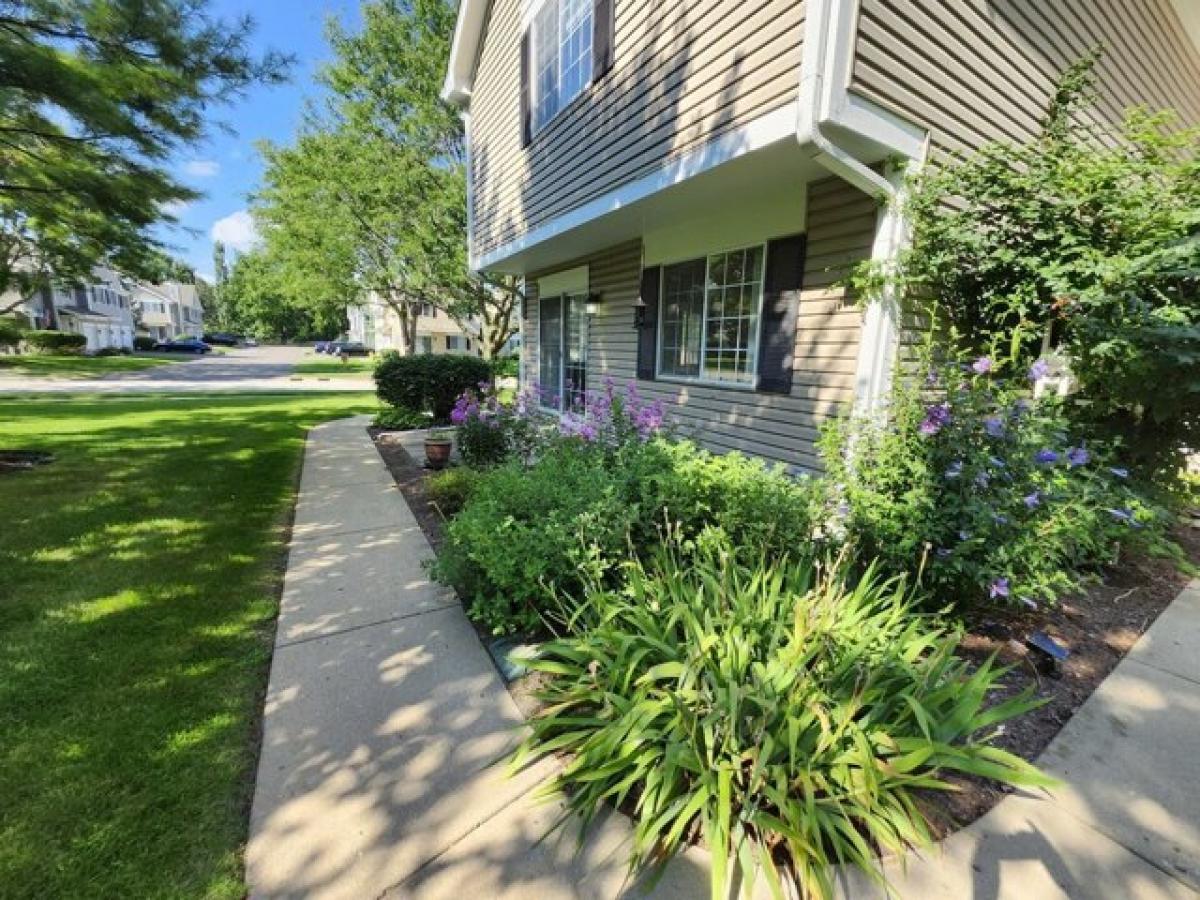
<box><xmin>444</xmin><ymin>0</ymin><xmax>1200</xmax><ymax>469</ymax></box>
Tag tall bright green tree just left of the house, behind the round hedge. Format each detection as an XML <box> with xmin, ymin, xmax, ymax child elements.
<box><xmin>256</xmin><ymin>0</ymin><xmax>520</xmax><ymax>355</ymax></box>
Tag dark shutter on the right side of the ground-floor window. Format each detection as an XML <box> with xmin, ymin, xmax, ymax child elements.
<box><xmin>758</xmin><ymin>234</ymin><xmax>804</xmax><ymax>394</ymax></box>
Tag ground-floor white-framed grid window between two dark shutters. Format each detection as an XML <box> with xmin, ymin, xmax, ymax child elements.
<box><xmin>659</xmin><ymin>246</ymin><xmax>764</xmax><ymax>386</ymax></box>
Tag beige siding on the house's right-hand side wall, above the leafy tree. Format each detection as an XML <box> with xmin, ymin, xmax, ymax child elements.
<box><xmin>850</xmin><ymin>0</ymin><xmax>1200</xmax><ymax>158</ymax></box>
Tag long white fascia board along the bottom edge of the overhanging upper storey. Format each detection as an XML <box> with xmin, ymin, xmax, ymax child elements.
<box><xmin>470</xmin><ymin>102</ymin><xmax>797</xmax><ymax>271</ymax></box>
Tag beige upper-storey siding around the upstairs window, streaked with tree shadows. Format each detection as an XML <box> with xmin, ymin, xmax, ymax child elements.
<box><xmin>470</xmin><ymin>0</ymin><xmax>804</xmax><ymax>260</ymax></box>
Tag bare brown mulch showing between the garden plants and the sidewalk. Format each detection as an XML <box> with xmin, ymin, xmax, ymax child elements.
<box><xmin>371</xmin><ymin>430</ymin><xmax>1200</xmax><ymax>836</ymax></box>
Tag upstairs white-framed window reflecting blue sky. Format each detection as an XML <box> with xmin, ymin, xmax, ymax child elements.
<box><xmin>533</xmin><ymin>0</ymin><xmax>594</xmax><ymax>131</ymax></box>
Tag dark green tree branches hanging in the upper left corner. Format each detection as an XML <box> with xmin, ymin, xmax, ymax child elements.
<box><xmin>0</xmin><ymin>0</ymin><xmax>288</xmax><ymax>314</ymax></box>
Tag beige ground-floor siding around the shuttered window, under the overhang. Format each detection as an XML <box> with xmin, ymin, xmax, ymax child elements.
<box><xmin>522</xmin><ymin>179</ymin><xmax>877</xmax><ymax>470</ymax></box>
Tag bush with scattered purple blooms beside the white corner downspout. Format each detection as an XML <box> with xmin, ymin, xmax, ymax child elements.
<box><xmin>822</xmin><ymin>358</ymin><xmax>1163</xmax><ymax>606</ymax></box>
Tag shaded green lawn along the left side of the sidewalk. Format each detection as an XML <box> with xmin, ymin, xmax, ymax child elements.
<box><xmin>0</xmin><ymin>394</ymin><xmax>376</xmax><ymax>898</ymax></box>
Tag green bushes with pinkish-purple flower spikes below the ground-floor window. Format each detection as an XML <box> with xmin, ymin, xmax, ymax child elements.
<box><xmin>432</xmin><ymin>383</ymin><xmax>821</xmax><ymax>634</ymax></box>
